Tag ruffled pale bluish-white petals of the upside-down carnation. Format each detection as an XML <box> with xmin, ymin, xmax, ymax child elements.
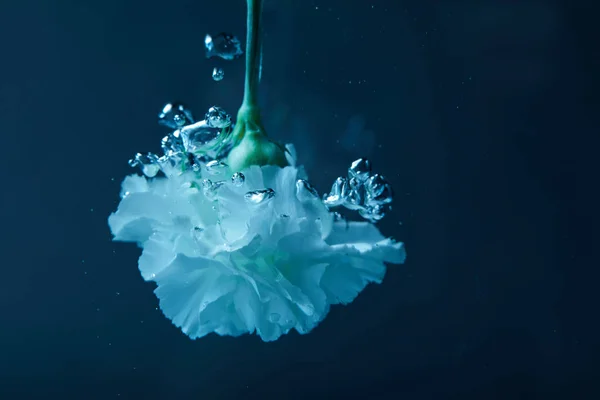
<box><xmin>109</xmin><ymin>146</ymin><xmax>405</xmax><ymax>341</ymax></box>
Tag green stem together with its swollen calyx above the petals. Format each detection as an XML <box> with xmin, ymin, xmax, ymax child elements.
<box><xmin>227</xmin><ymin>0</ymin><xmax>288</xmax><ymax>171</ymax></box>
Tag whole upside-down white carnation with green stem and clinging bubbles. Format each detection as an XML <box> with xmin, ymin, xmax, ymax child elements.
<box><xmin>108</xmin><ymin>0</ymin><xmax>406</xmax><ymax>341</ymax></box>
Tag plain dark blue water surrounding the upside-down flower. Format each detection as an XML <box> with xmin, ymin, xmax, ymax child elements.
<box><xmin>0</xmin><ymin>0</ymin><xmax>600</xmax><ymax>400</ymax></box>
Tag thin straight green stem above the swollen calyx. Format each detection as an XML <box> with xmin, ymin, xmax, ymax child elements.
<box><xmin>242</xmin><ymin>0</ymin><xmax>263</xmax><ymax>113</ymax></box>
